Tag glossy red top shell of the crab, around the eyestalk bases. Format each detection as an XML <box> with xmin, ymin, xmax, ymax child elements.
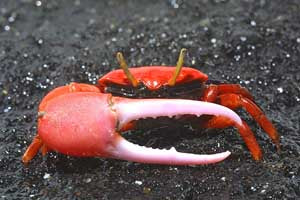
<box><xmin>98</xmin><ymin>66</ymin><xmax>208</xmax><ymax>90</ymax></box>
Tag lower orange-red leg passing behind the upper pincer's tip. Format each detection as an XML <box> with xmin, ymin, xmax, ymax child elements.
<box><xmin>201</xmin><ymin>116</ymin><xmax>262</xmax><ymax>160</ymax></box>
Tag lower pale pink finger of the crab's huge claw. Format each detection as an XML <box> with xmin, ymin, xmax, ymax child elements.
<box><xmin>111</xmin><ymin>136</ymin><xmax>230</xmax><ymax>165</ymax></box>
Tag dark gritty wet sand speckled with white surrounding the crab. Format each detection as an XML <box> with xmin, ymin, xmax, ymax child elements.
<box><xmin>0</xmin><ymin>0</ymin><xmax>300</xmax><ymax>199</ymax></box>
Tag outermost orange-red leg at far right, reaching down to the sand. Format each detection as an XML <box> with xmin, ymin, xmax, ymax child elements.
<box><xmin>218</xmin><ymin>94</ymin><xmax>279</xmax><ymax>149</ymax></box>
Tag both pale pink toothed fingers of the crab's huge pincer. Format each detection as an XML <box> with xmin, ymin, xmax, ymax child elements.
<box><xmin>110</xmin><ymin>99</ymin><xmax>242</xmax><ymax>165</ymax></box>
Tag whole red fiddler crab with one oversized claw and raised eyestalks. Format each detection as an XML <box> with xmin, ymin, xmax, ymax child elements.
<box><xmin>22</xmin><ymin>49</ymin><xmax>279</xmax><ymax>165</ymax></box>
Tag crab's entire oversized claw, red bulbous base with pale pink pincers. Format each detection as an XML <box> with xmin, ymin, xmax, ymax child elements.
<box><xmin>38</xmin><ymin>92</ymin><xmax>242</xmax><ymax>165</ymax></box>
